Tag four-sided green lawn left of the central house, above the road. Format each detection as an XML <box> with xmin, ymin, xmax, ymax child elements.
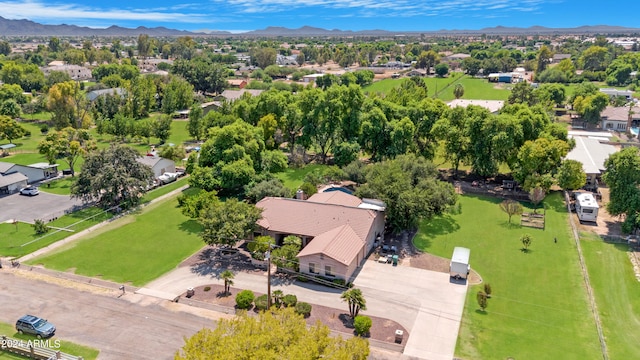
<box><xmin>26</xmin><ymin>190</ymin><xmax>203</xmax><ymax>286</ymax></box>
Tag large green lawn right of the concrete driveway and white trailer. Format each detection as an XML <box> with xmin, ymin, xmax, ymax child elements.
<box><xmin>415</xmin><ymin>193</ymin><xmax>602</xmax><ymax>360</ymax></box>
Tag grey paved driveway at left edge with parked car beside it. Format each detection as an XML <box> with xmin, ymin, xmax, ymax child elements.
<box><xmin>0</xmin><ymin>191</ymin><xmax>82</xmax><ymax>223</ymax></box>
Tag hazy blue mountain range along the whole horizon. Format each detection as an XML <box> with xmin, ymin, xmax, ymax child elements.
<box><xmin>0</xmin><ymin>17</ymin><xmax>640</xmax><ymax>37</ymax></box>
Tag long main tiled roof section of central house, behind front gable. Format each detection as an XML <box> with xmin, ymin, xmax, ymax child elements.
<box><xmin>256</xmin><ymin>197</ymin><xmax>377</xmax><ymax>241</ymax></box>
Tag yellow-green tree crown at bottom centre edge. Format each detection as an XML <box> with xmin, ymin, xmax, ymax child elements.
<box><xmin>175</xmin><ymin>308</ymin><xmax>369</xmax><ymax>360</ymax></box>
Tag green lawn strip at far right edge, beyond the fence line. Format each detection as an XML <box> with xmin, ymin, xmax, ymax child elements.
<box><xmin>581</xmin><ymin>234</ymin><xmax>640</xmax><ymax>359</ymax></box>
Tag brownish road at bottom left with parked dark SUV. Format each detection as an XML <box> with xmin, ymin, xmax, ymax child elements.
<box><xmin>0</xmin><ymin>268</ymin><xmax>226</xmax><ymax>360</ymax></box>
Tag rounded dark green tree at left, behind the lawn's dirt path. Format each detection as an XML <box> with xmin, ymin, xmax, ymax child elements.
<box><xmin>71</xmin><ymin>145</ymin><xmax>153</xmax><ymax>208</ymax></box>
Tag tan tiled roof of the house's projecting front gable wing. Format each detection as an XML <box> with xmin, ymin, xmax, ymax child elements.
<box><xmin>298</xmin><ymin>225</ymin><xmax>364</xmax><ymax>265</ymax></box>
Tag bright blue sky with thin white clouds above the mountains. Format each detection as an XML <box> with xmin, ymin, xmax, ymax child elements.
<box><xmin>0</xmin><ymin>0</ymin><xmax>640</xmax><ymax>32</ymax></box>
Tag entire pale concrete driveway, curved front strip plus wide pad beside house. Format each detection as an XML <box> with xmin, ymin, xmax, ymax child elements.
<box><xmin>138</xmin><ymin>260</ymin><xmax>467</xmax><ymax>360</ymax></box>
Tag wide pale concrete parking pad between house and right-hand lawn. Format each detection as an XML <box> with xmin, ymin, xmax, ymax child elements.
<box><xmin>354</xmin><ymin>261</ymin><xmax>467</xmax><ymax>360</ymax></box>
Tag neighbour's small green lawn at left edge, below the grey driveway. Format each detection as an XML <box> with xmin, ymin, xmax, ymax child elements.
<box><xmin>0</xmin><ymin>208</ymin><xmax>112</xmax><ymax>257</ymax></box>
